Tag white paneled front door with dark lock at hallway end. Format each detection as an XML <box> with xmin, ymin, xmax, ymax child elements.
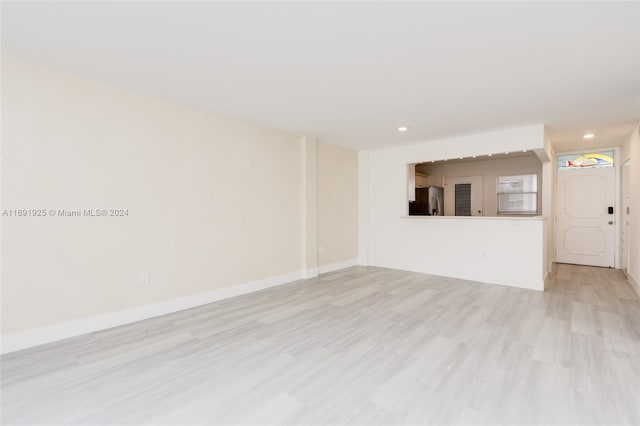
<box><xmin>556</xmin><ymin>167</ymin><xmax>616</xmax><ymax>268</ymax></box>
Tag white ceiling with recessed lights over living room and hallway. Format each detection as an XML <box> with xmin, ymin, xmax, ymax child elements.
<box><xmin>2</xmin><ymin>2</ymin><xmax>640</xmax><ymax>151</ymax></box>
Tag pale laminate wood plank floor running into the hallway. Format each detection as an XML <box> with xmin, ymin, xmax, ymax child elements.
<box><xmin>1</xmin><ymin>265</ymin><xmax>640</xmax><ymax>425</ymax></box>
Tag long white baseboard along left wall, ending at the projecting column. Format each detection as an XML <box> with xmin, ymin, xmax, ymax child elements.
<box><xmin>0</xmin><ymin>271</ymin><xmax>304</xmax><ymax>354</ymax></box>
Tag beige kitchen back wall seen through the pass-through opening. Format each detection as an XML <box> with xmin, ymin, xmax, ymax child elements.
<box><xmin>416</xmin><ymin>154</ymin><xmax>542</xmax><ymax>216</ymax></box>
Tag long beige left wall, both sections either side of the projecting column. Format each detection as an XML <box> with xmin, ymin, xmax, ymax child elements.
<box><xmin>1</xmin><ymin>58</ymin><xmax>357</xmax><ymax>334</ymax></box>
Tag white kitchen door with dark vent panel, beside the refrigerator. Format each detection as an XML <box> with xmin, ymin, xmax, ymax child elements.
<box><xmin>444</xmin><ymin>176</ymin><xmax>484</xmax><ymax>216</ymax></box>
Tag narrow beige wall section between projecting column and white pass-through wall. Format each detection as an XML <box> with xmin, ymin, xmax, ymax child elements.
<box><xmin>317</xmin><ymin>143</ymin><xmax>358</xmax><ymax>266</ymax></box>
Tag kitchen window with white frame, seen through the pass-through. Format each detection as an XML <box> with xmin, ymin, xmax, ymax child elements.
<box><xmin>498</xmin><ymin>173</ymin><xmax>538</xmax><ymax>214</ymax></box>
